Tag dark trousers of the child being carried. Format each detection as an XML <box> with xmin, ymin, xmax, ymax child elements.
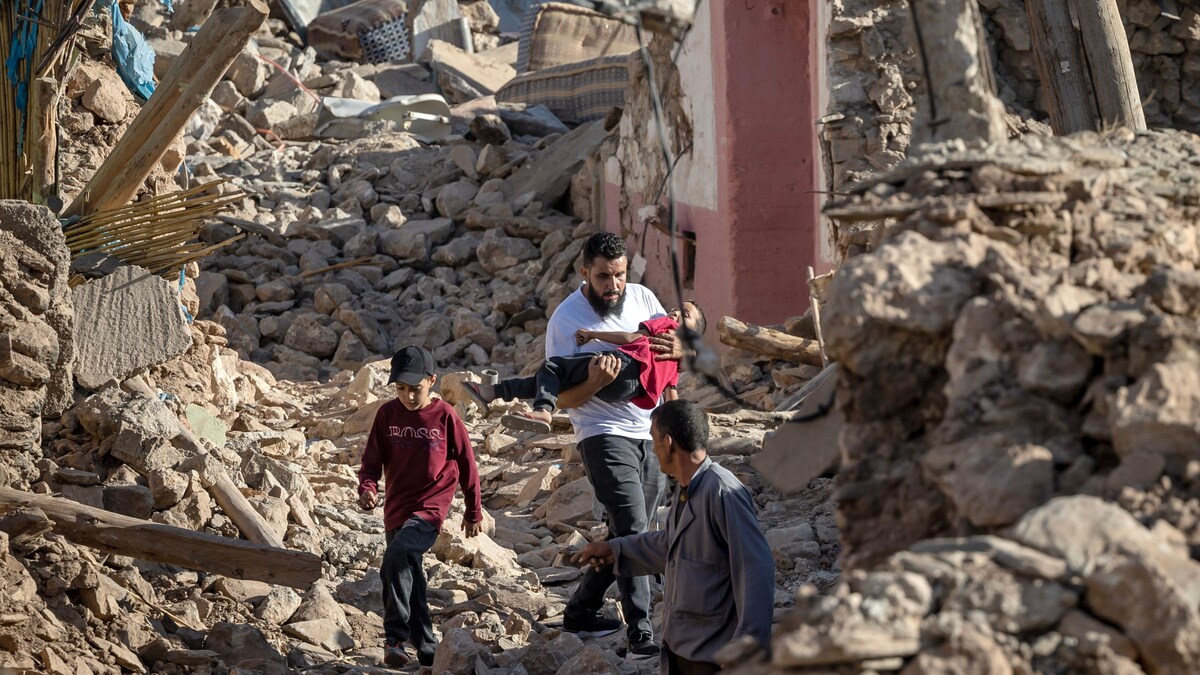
<box><xmin>496</xmin><ymin>351</ymin><xmax>643</xmax><ymax>411</ymax></box>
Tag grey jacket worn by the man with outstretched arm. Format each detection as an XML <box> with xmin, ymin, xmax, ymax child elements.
<box><xmin>608</xmin><ymin>459</ymin><xmax>775</xmax><ymax>663</ymax></box>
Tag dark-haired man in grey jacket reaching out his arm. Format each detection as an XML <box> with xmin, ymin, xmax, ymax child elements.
<box><xmin>574</xmin><ymin>400</ymin><xmax>775</xmax><ymax>675</ymax></box>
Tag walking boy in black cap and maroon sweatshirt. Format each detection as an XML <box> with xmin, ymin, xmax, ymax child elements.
<box><xmin>359</xmin><ymin>347</ymin><xmax>484</xmax><ymax>668</ymax></box>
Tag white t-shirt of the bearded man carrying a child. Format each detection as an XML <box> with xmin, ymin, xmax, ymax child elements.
<box><xmin>546</xmin><ymin>283</ymin><xmax>667</xmax><ymax>442</ymax></box>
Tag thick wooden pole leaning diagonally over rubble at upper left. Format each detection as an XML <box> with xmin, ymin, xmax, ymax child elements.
<box><xmin>66</xmin><ymin>0</ymin><xmax>269</xmax><ymax>216</ymax></box>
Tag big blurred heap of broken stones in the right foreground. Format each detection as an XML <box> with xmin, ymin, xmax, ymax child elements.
<box><xmin>758</xmin><ymin>130</ymin><xmax>1200</xmax><ymax>675</ymax></box>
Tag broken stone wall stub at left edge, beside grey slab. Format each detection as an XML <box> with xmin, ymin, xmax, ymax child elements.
<box><xmin>0</xmin><ymin>201</ymin><xmax>74</xmax><ymax>485</ymax></box>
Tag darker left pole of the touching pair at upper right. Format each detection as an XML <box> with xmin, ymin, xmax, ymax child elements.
<box><xmin>1025</xmin><ymin>0</ymin><xmax>1099</xmax><ymax>136</ymax></box>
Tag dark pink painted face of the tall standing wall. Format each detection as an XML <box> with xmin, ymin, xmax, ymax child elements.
<box><xmin>697</xmin><ymin>0</ymin><xmax>828</xmax><ymax>323</ymax></box>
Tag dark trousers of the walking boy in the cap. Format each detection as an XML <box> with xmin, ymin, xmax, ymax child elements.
<box><xmin>379</xmin><ymin>515</ymin><xmax>438</xmax><ymax>657</ymax></box>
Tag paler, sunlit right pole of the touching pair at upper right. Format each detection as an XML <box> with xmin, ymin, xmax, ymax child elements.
<box><xmin>1075</xmin><ymin>0</ymin><xmax>1146</xmax><ymax>131</ymax></box>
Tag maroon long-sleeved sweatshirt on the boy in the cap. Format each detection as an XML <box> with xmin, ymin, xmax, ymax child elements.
<box><xmin>359</xmin><ymin>399</ymin><xmax>484</xmax><ymax>530</ymax></box>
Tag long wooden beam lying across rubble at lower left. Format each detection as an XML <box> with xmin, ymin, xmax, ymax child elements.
<box><xmin>0</xmin><ymin>488</ymin><xmax>320</xmax><ymax>589</ymax></box>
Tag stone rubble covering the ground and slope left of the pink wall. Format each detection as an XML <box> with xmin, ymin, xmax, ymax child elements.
<box><xmin>0</xmin><ymin>2</ymin><xmax>839</xmax><ymax>675</ymax></box>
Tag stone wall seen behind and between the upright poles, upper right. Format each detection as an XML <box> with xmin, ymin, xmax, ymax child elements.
<box><xmin>822</xmin><ymin>0</ymin><xmax>1200</xmax><ymax>201</ymax></box>
